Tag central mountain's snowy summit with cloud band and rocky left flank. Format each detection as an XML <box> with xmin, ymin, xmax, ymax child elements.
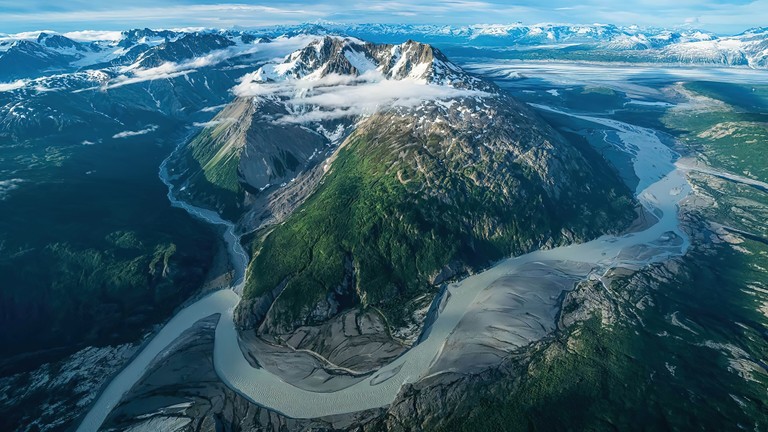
<box><xmin>177</xmin><ymin>36</ymin><xmax>493</xmax><ymax>217</ymax></box>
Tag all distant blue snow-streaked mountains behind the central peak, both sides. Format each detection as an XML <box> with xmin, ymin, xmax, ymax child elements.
<box><xmin>0</xmin><ymin>23</ymin><xmax>768</xmax><ymax>151</ymax></box>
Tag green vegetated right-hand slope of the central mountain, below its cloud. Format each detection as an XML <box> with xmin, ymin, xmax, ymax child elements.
<box><xmin>245</xmin><ymin>102</ymin><xmax>633</xmax><ymax>334</ymax></box>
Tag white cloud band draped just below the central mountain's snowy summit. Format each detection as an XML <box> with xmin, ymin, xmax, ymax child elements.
<box><xmin>233</xmin><ymin>70</ymin><xmax>488</xmax><ymax>123</ymax></box>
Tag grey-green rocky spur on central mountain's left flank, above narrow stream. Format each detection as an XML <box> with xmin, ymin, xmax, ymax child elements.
<box><xmin>182</xmin><ymin>94</ymin><xmax>329</xmax><ymax>218</ymax></box>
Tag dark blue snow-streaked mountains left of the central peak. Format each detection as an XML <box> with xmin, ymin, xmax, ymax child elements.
<box><xmin>0</xmin><ymin>29</ymin><xmax>314</xmax><ymax>136</ymax></box>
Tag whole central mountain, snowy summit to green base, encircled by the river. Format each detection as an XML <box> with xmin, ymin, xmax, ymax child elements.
<box><xmin>171</xmin><ymin>37</ymin><xmax>633</xmax><ymax>369</ymax></box>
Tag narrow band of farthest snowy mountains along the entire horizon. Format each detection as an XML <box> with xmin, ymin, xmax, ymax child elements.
<box><xmin>0</xmin><ymin>23</ymin><xmax>768</xmax><ymax>82</ymax></box>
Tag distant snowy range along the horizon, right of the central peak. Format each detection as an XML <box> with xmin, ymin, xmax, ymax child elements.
<box><xmin>306</xmin><ymin>23</ymin><xmax>768</xmax><ymax>68</ymax></box>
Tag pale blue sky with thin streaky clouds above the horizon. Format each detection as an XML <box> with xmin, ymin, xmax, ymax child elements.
<box><xmin>0</xmin><ymin>0</ymin><xmax>768</xmax><ymax>33</ymax></box>
